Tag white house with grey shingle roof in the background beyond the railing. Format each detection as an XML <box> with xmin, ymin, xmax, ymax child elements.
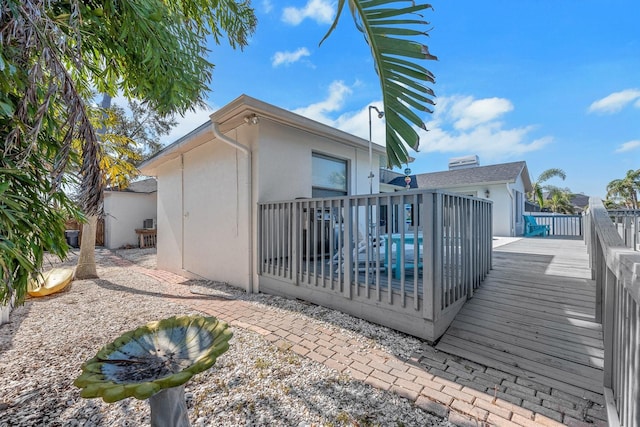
<box><xmin>389</xmin><ymin>156</ymin><xmax>532</xmax><ymax>236</ymax></box>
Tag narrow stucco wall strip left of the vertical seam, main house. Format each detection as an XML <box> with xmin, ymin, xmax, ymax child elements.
<box><xmin>157</xmin><ymin>157</ymin><xmax>182</xmax><ymax>274</ymax></box>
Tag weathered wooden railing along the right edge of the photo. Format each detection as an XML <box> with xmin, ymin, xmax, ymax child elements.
<box><xmin>586</xmin><ymin>198</ymin><xmax>640</xmax><ymax>426</ymax></box>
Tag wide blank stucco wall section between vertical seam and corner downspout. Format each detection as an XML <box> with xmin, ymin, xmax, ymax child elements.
<box><xmin>183</xmin><ymin>140</ymin><xmax>250</xmax><ymax>288</ymax></box>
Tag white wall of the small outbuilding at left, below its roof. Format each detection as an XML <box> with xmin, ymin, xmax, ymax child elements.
<box><xmin>104</xmin><ymin>191</ymin><xmax>157</xmax><ymax>249</ymax></box>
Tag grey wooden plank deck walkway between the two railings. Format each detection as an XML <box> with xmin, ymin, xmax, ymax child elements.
<box><xmin>437</xmin><ymin>237</ymin><xmax>604</xmax><ymax>398</ymax></box>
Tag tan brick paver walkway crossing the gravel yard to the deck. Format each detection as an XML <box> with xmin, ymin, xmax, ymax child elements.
<box><xmin>107</xmin><ymin>242</ymin><xmax>606</xmax><ymax>427</ymax></box>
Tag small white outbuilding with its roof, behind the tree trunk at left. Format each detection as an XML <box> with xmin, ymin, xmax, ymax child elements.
<box><xmin>104</xmin><ymin>178</ymin><xmax>158</xmax><ymax>249</ymax></box>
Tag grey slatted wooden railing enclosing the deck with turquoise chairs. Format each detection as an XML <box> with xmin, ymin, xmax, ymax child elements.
<box><xmin>258</xmin><ymin>190</ymin><xmax>492</xmax><ymax>341</ymax></box>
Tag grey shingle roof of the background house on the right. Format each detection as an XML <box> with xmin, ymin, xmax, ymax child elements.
<box><xmin>389</xmin><ymin>161</ymin><xmax>531</xmax><ymax>191</ymax></box>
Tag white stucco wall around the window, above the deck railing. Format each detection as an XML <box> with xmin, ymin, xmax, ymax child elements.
<box><xmin>254</xmin><ymin>120</ymin><xmax>379</xmax><ymax>202</ymax></box>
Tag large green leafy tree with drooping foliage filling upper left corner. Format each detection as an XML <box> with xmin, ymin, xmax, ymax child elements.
<box><xmin>0</xmin><ymin>0</ymin><xmax>256</xmax><ymax>302</ymax></box>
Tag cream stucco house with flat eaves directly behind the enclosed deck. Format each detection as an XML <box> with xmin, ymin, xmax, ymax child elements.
<box><xmin>139</xmin><ymin>95</ymin><xmax>384</xmax><ymax>291</ymax></box>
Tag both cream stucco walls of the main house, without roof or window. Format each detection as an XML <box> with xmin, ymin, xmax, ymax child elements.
<box><xmin>157</xmin><ymin>118</ymin><xmax>378</xmax><ymax>290</ymax></box>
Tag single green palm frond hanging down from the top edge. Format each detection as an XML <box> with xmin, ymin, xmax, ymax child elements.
<box><xmin>320</xmin><ymin>0</ymin><xmax>437</xmax><ymax>166</ymax></box>
